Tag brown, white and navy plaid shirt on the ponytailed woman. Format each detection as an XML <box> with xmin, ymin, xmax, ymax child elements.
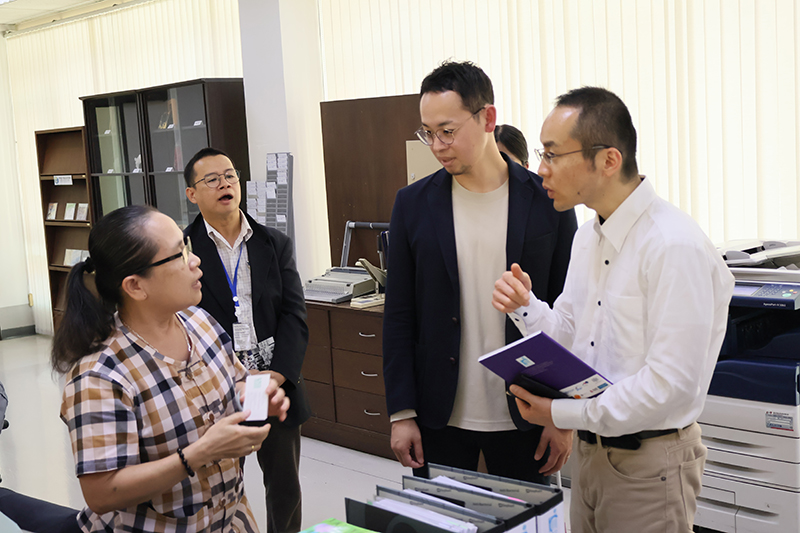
<box><xmin>61</xmin><ymin>307</ymin><xmax>258</xmax><ymax>533</ymax></box>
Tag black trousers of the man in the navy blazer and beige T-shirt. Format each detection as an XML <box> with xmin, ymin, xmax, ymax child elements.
<box><xmin>414</xmin><ymin>426</ymin><xmax>550</xmax><ymax>485</ymax></box>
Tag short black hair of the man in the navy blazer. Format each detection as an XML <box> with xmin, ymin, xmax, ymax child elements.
<box><xmin>419</xmin><ymin>61</ymin><xmax>494</xmax><ymax>113</ymax></box>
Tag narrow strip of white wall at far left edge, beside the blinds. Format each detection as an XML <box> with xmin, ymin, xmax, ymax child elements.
<box><xmin>0</xmin><ymin>39</ymin><xmax>32</xmax><ymax>329</ymax></box>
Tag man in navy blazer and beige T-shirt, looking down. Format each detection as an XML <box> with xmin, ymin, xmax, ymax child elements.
<box><xmin>383</xmin><ymin>62</ymin><xmax>577</xmax><ymax>482</ymax></box>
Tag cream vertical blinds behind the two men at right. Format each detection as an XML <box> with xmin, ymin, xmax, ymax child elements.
<box><xmin>319</xmin><ymin>0</ymin><xmax>800</xmax><ymax>242</ymax></box>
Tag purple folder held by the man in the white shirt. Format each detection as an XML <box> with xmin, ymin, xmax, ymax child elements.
<box><xmin>478</xmin><ymin>331</ymin><xmax>611</xmax><ymax>398</ymax></box>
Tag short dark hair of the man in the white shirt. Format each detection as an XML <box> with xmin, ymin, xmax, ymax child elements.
<box><xmin>556</xmin><ymin>87</ymin><xmax>639</xmax><ymax>180</ymax></box>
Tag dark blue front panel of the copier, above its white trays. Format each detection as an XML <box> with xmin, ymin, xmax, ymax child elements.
<box><xmin>708</xmin><ymin>358</ymin><xmax>800</xmax><ymax>406</ymax></box>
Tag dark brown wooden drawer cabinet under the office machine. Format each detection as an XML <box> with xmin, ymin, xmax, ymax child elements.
<box><xmin>302</xmin><ymin>302</ymin><xmax>394</xmax><ymax>459</ymax></box>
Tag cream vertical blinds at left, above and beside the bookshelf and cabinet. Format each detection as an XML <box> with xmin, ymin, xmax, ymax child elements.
<box><xmin>6</xmin><ymin>0</ymin><xmax>242</xmax><ymax>333</ymax></box>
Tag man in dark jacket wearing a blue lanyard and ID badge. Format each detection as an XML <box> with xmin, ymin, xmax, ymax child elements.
<box><xmin>184</xmin><ymin>148</ymin><xmax>310</xmax><ymax>533</ymax></box>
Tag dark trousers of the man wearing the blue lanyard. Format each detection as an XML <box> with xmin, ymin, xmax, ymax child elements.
<box><xmin>256</xmin><ymin>418</ymin><xmax>303</xmax><ymax>533</ymax></box>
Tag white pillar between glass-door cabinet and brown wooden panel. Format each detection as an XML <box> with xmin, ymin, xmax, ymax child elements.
<box><xmin>239</xmin><ymin>0</ymin><xmax>330</xmax><ymax>279</ymax></box>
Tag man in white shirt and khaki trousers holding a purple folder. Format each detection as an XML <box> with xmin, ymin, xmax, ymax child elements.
<box><xmin>493</xmin><ymin>87</ymin><xmax>733</xmax><ymax>533</ymax></box>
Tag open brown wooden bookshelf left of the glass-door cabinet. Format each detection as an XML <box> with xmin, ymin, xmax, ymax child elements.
<box><xmin>36</xmin><ymin>127</ymin><xmax>94</xmax><ymax>328</ymax></box>
